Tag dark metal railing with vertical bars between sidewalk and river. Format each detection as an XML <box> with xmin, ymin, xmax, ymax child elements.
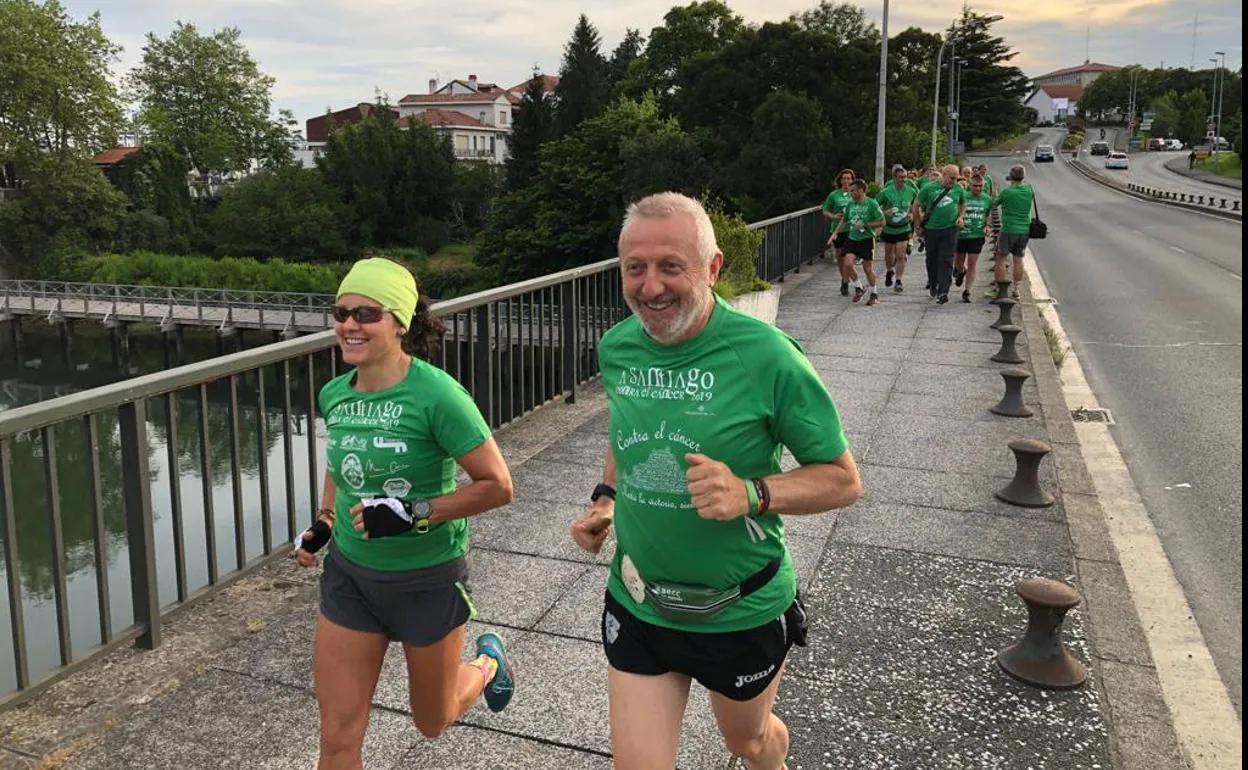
<box><xmin>0</xmin><ymin>202</ymin><xmax>826</xmax><ymax>705</ymax></box>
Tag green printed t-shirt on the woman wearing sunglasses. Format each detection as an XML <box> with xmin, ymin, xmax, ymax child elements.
<box><xmin>319</xmin><ymin>358</ymin><xmax>489</xmax><ymax>570</ymax></box>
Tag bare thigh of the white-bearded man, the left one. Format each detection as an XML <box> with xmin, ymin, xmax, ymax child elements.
<box><xmin>607</xmin><ymin>665</ymin><xmax>693</xmax><ymax>770</ymax></box>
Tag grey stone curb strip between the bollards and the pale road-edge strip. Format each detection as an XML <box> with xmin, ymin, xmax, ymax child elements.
<box><xmin>1018</xmin><ymin>273</ymin><xmax>1192</xmax><ymax>770</ymax></box>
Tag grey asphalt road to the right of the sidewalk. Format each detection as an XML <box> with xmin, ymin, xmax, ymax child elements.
<box><xmin>985</xmin><ymin>127</ymin><xmax>1243</xmax><ymax>715</ymax></box>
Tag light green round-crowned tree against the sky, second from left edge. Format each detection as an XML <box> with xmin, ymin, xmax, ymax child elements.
<box><xmin>126</xmin><ymin>21</ymin><xmax>291</xmax><ymax>173</ymax></box>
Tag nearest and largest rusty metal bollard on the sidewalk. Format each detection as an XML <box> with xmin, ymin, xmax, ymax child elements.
<box><xmin>997</xmin><ymin>578</ymin><xmax>1088</xmax><ymax>690</ymax></box>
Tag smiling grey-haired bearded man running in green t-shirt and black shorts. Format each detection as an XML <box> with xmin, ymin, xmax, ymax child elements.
<box><xmin>570</xmin><ymin>192</ymin><xmax>862</xmax><ymax>770</ymax></box>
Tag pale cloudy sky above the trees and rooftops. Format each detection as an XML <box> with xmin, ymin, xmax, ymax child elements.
<box><xmin>64</xmin><ymin>0</ymin><xmax>1243</xmax><ymax>122</ymax></box>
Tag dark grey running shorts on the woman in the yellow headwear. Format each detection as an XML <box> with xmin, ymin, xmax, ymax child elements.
<box><xmin>321</xmin><ymin>542</ymin><xmax>477</xmax><ymax>646</ymax></box>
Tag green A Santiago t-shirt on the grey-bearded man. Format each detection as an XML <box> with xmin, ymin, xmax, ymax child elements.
<box><xmin>599</xmin><ymin>297</ymin><xmax>849</xmax><ymax>633</ymax></box>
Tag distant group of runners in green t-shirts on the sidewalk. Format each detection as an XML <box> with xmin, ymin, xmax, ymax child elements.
<box><xmin>822</xmin><ymin>163</ymin><xmax>1035</xmax><ymax>305</ymax></box>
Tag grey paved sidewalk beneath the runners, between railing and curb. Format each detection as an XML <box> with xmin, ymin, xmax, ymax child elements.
<box><xmin>0</xmin><ymin>255</ymin><xmax>1184</xmax><ymax>770</ymax></box>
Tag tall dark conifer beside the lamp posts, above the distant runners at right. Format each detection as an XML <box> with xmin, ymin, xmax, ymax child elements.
<box><xmin>957</xmin><ymin>9</ymin><xmax>1031</xmax><ymax>146</ymax></box>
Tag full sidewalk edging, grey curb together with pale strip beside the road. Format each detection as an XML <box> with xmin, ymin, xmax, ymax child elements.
<box><xmin>1022</xmin><ymin>261</ymin><xmax>1242</xmax><ymax>770</ymax></box>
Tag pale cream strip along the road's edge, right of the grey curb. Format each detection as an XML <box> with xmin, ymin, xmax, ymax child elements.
<box><xmin>1025</xmin><ymin>260</ymin><xmax>1243</xmax><ymax>770</ymax></box>
